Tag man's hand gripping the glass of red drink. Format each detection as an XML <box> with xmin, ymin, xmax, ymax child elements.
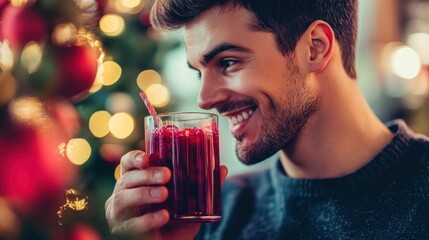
<box><xmin>105</xmin><ymin>151</ymin><xmax>228</xmax><ymax>240</ymax></box>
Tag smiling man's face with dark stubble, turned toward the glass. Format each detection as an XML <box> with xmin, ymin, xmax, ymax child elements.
<box><xmin>184</xmin><ymin>5</ymin><xmax>317</xmax><ymax>164</ymax></box>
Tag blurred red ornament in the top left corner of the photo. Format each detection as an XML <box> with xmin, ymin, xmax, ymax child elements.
<box><xmin>0</xmin><ymin>5</ymin><xmax>48</xmax><ymax>48</ymax></box>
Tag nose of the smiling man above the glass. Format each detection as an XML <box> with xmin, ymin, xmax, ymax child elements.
<box><xmin>198</xmin><ymin>71</ymin><xmax>229</xmax><ymax>110</ymax></box>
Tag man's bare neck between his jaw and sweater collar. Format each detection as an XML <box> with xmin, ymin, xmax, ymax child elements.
<box><xmin>280</xmin><ymin>77</ymin><xmax>392</xmax><ymax>179</ymax></box>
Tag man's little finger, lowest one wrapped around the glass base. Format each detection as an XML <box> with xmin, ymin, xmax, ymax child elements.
<box><xmin>112</xmin><ymin>209</ymin><xmax>170</xmax><ymax>239</ymax></box>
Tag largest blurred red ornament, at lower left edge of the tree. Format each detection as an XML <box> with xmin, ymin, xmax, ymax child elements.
<box><xmin>0</xmin><ymin>98</ymin><xmax>79</xmax><ymax>217</ymax></box>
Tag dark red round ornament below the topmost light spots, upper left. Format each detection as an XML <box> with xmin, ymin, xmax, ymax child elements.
<box><xmin>52</xmin><ymin>46</ymin><xmax>98</xmax><ymax>98</ymax></box>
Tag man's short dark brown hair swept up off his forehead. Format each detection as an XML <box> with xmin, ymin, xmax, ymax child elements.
<box><xmin>152</xmin><ymin>0</ymin><xmax>358</xmax><ymax>78</ymax></box>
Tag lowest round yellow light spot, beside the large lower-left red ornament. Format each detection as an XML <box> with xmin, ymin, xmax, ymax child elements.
<box><xmin>66</xmin><ymin>138</ymin><xmax>92</xmax><ymax>165</ymax></box>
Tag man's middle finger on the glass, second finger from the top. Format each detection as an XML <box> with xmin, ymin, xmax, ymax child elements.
<box><xmin>113</xmin><ymin>167</ymin><xmax>171</xmax><ymax>193</ymax></box>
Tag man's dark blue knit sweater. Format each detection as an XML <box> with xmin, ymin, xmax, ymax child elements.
<box><xmin>197</xmin><ymin>120</ymin><xmax>429</xmax><ymax>240</ymax></box>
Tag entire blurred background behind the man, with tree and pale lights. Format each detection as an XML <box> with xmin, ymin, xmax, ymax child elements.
<box><xmin>0</xmin><ymin>0</ymin><xmax>429</xmax><ymax>240</ymax></box>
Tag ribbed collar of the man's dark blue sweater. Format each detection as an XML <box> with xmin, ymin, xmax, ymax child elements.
<box><xmin>270</xmin><ymin>120</ymin><xmax>415</xmax><ymax>197</ymax></box>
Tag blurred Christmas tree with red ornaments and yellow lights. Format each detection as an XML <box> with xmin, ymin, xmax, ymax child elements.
<box><xmin>0</xmin><ymin>0</ymin><xmax>178</xmax><ymax>237</ymax></box>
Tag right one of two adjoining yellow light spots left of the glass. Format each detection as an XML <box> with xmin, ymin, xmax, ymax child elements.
<box><xmin>109</xmin><ymin>112</ymin><xmax>134</xmax><ymax>139</ymax></box>
